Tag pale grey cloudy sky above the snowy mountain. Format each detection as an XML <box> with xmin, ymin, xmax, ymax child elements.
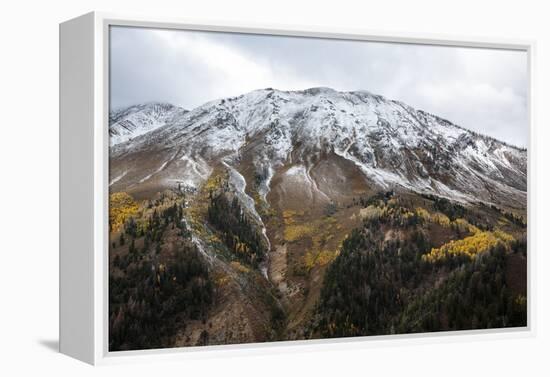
<box><xmin>110</xmin><ymin>27</ymin><xmax>528</xmax><ymax>147</ymax></box>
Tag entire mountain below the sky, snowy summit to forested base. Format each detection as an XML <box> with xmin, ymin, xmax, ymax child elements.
<box><xmin>109</xmin><ymin>88</ymin><xmax>527</xmax><ymax>350</ymax></box>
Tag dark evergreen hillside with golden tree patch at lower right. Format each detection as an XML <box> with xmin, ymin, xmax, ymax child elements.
<box><xmin>312</xmin><ymin>193</ymin><xmax>527</xmax><ymax>337</ymax></box>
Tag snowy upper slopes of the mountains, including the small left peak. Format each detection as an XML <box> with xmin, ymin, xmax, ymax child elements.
<box><xmin>110</xmin><ymin>88</ymin><xmax>527</xmax><ymax>207</ymax></box>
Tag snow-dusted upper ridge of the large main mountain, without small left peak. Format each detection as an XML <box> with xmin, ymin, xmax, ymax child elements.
<box><xmin>111</xmin><ymin>87</ymin><xmax>527</xmax><ymax>206</ymax></box>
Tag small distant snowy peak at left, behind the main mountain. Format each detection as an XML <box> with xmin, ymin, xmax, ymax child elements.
<box><xmin>109</xmin><ymin>102</ymin><xmax>187</xmax><ymax>146</ymax></box>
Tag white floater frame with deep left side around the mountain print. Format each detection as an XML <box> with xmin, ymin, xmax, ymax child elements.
<box><xmin>59</xmin><ymin>12</ymin><xmax>536</xmax><ymax>364</ymax></box>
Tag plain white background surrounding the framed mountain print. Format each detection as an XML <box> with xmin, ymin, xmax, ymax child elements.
<box><xmin>0</xmin><ymin>0</ymin><xmax>550</xmax><ymax>377</ymax></box>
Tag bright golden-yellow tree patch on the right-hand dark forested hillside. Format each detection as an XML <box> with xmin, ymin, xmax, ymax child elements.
<box><xmin>422</xmin><ymin>230</ymin><xmax>514</xmax><ymax>262</ymax></box>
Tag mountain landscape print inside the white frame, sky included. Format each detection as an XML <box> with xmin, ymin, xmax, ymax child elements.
<box><xmin>108</xmin><ymin>26</ymin><xmax>528</xmax><ymax>351</ymax></box>
